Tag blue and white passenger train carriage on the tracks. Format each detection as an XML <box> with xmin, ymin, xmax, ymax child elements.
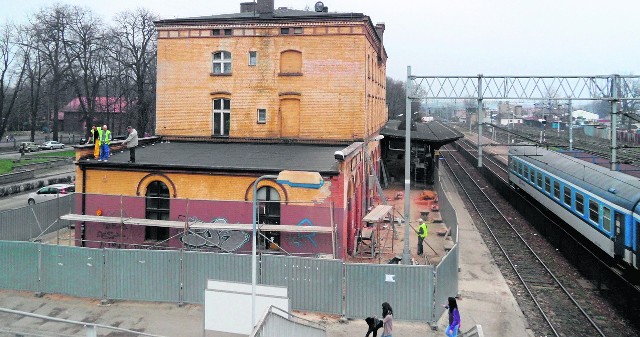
<box><xmin>509</xmin><ymin>145</ymin><xmax>640</xmax><ymax>269</ymax></box>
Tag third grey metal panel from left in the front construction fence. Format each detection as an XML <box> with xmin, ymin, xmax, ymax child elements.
<box><xmin>105</xmin><ymin>249</ymin><xmax>180</xmax><ymax>302</ymax></box>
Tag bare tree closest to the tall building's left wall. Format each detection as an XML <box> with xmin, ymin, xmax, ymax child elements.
<box><xmin>111</xmin><ymin>9</ymin><xmax>158</xmax><ymax>134</ymax></box>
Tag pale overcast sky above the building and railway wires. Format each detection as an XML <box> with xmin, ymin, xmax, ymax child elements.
<box><xmin>0</xmin><ymin>0</ymin><xmax>640</xmax><ymax>80</ymax></box>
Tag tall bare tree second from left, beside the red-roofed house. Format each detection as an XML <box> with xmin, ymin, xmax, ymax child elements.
<box><xmin>30</xmin><ymin>4</ymin><xmax>73</xmax><ymax>140</ymax></box>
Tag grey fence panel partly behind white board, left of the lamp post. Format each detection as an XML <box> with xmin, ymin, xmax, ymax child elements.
<box><xmin>182</xmin><ymin>252</ymin><xmax>251</xmax><ymax>304</ymax></box>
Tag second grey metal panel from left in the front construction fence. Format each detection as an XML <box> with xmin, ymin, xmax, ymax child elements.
<box><xmin>41</xmin><ymin>245</ymin><xmax>104</xmax><ymax>298</ymax></box>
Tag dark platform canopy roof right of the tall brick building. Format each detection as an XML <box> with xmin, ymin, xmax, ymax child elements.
<box><xmin>380</xmin><ymin>119</ymin><xmax>464</xmax><ymax>146</ymax></box>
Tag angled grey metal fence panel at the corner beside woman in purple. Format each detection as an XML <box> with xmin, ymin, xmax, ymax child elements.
<box><xmin>432</xmin><ymin>244</ymin><xmax>460</xmax><ymax>321</ymax></box>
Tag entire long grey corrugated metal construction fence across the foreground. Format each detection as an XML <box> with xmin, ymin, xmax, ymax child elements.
<box><xmin>0</xmin><ymin>241</ymin><xmax>458</xmax><ymax>323</ymax></box>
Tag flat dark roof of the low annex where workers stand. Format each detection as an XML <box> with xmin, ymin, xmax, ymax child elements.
<box><xmin>78</xmin><ymin>142</ymin><xmax>344</xmax><ymax>175</ymax></box>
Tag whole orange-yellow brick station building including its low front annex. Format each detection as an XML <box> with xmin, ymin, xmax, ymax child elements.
<box><xmin>76</xmin><ymin>0</ymin><xmax>387</xmax><ymax>257</ymax></box>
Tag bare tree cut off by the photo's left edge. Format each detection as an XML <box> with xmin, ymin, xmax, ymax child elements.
<box><xmin>0</xmin><ymin>24</ymin><xmax>26</xmax><ymax>139</ymax></box>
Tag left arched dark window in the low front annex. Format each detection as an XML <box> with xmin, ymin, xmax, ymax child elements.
<box><xmin>144</xmin><ymin>181</ymin><xmax>170</xmax><ymax>241</ymax></box>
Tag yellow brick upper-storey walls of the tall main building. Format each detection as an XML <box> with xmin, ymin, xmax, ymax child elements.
<box><xmin>156</xmin><ymin>19</ymin><xmax>387</xmax><ymax>140</ymax></box>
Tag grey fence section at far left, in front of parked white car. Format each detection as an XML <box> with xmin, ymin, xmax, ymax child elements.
<box><xmin>0</xmin><ymin>194</ymin><xmax>75</xmax><ymax>241</ymax></box>
